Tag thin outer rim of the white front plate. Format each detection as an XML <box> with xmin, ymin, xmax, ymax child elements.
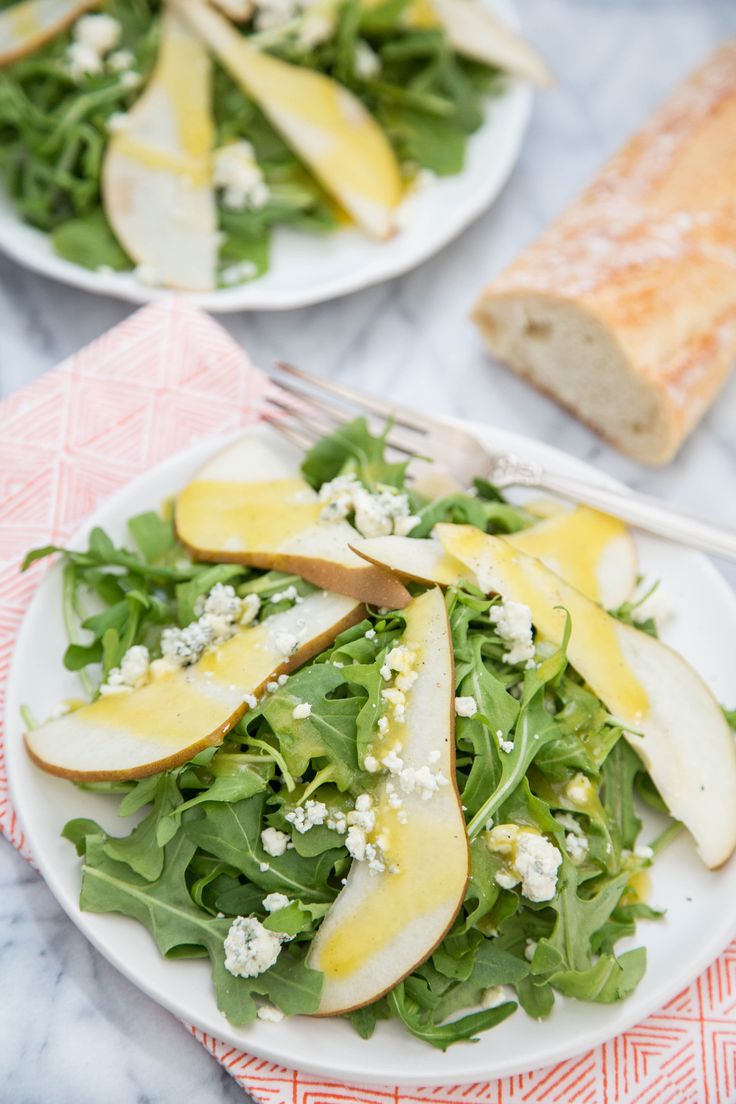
<box><xmin>4</xmin><ymin>417</ymin><xmax>736</xmax><ymax>1087</ymax></box>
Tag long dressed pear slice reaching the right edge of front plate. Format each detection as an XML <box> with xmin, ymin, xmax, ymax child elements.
<box><xmin>437</xmin><ymin>524</ymin><xmax>736</xmax><ymax>867</ymax></box>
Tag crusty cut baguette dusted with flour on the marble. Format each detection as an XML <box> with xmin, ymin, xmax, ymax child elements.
<box><xmin>473</xmin><ymin>40</ymin><xmax>736</xmax><ymax>464</ymax></box>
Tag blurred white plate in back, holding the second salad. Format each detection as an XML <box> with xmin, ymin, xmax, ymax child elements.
<box><xmin>0</xmin><ymin>0</ymin><xmax>532</xmax><ymax>314</ymax></box>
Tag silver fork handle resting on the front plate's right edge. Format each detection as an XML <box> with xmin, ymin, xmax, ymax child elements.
<box><xmin>534</xmin><ymin>471</ymin><xmax>736</xmax><ymax>560</ymax></box>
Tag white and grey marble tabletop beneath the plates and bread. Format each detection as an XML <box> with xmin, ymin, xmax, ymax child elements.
<box><xmin>0</xmin><ymin>0</ymin><xmax>736</xmax><ymax>1104</ymax></box>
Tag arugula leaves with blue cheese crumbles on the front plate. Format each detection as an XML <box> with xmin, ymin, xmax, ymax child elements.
<box><xmin>20</xmin><ymin>421</ymin><xmax>733</xmax><ymax>1049</ymax></box>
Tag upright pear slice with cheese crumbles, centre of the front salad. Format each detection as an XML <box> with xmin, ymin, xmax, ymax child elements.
<box><xmin>309</xmin><ymin>588</ymin><xmax>468</xmax><ymax>1016</ymax></box>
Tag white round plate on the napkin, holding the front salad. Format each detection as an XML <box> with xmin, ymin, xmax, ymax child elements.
<box><xmin>6</xmin><ymin>426</ymin><xmax>736</xmax><ymax>1085</ymax></box>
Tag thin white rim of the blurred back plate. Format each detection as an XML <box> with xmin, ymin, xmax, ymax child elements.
<box><xmin>0</xmin><ymin>0</ymin><xmax>534</xmax><ymax>315</ymax></box>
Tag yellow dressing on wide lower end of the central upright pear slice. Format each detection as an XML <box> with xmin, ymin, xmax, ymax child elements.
<box><xmin>319</xmin><ymin>807</ymin><xmax>458</xmax><ymax>978</ymax></box>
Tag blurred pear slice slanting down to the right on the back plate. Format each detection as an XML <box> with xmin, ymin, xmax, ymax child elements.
<box><xmin>173</xmin><ymin>0</ymin><xmax>402</xmax><ymax>237</ymax></box>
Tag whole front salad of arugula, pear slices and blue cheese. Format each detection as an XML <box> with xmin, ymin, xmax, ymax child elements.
<box><xmin>18</xmin><ymin>420</ymin><xmax>736</xmax><ymax>1049</ymax></box>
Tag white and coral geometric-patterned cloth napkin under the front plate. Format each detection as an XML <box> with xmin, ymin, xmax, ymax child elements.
<box><xmin>0</xmin><ymin>299</ymin><xmax>736</xmax><ymax>1104</ymax></box>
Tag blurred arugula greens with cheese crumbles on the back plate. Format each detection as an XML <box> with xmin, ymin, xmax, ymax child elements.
<box><xmin>0</xmin><ymin>0</ymin><xmax>501</xmax><ymax>286</ymax></box>
